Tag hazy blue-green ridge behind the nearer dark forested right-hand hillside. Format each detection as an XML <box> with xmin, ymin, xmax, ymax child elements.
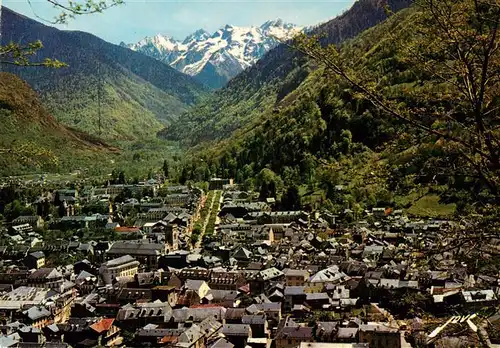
<box><xmin>160</xmin><ymin>0</ymin><xmax>412</xmax><ymax>145</ymax></box>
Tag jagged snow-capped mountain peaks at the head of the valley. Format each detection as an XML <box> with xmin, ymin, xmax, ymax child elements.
<box><xmin>122</xmin><ymin>19</ymin><xmax>302</xmax><ymax>88</ymax></box>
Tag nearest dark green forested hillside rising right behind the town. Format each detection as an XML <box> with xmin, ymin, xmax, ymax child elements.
<box><xmin>175</xmin><ymin>2</ymin><xmax>499</xmax><ymax>215</ymax></box>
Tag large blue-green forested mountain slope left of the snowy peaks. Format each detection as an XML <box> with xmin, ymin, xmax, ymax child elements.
<box><xmin>1</xmin><ymin>7</ymin><xmax>206</xmax><ymax>139</ymax></box>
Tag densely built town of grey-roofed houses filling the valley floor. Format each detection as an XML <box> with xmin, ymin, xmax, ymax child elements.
<box><xmin>0</xmin><ymin>178</ymin><xmax>500</xmax><ymax>348</ymax></box>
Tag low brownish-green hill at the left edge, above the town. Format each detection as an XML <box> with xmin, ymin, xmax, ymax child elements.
<box><xmin>0</xmin><ymin>73</ymin><xmax>118</xmax><ymax>175</ymax></box>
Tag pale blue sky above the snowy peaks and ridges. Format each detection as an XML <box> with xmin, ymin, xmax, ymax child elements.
<box><xmin>0</xmin><ymin>0</ymin><xmax>354</xmax><ymax>43</ymax></box>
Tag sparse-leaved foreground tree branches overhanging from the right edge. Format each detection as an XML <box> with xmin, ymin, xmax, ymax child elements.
<box><xmin>296</xmin><ymin>0</ymin><xmax>500</xmax><ymax>203</ymax></box>
